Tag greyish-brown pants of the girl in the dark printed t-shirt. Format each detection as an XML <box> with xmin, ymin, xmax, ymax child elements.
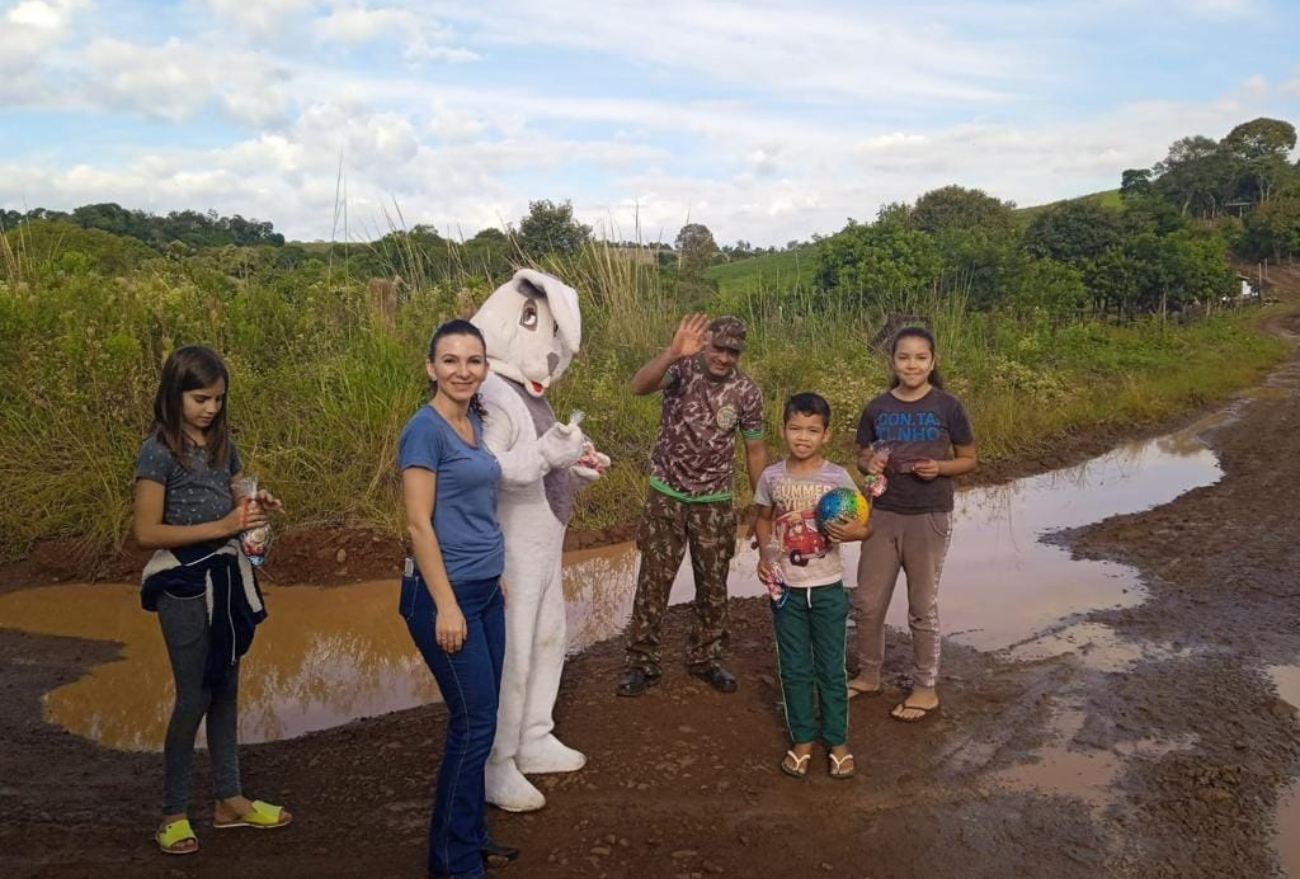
<box><xmin>853</xmin><ymin>510</ymin><xmax>952</xmax><ymax>688</ymax></box>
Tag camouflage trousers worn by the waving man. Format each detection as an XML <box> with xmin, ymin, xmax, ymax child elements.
<box><xmin>627</xmin><ymin>489</ymin><xmax>736</xmax><ymax>674</ymax></box>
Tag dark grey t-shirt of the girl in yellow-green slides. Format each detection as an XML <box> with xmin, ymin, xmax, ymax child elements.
<box><xmin>135</xmin><ymin>434</ymin><xmax>243</xmax><ymax>525</ymax></box>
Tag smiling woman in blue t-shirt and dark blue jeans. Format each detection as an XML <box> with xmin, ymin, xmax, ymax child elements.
<box><xmin>398</xmin><ymin>320</ymin><xmax>519</xmax><ymax>879</ymax></box>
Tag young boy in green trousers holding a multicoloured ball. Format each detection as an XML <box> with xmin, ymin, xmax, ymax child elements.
<box><xmin>754</xmin><ymin>394</ymin><xmax>871</xmax><ymax>779</ymax></box>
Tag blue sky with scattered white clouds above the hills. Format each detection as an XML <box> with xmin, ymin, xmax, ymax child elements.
<box><xmin>0</xmin><ymin>0</ymin><xmax>1300</xmax><ymax>246</ymax></box>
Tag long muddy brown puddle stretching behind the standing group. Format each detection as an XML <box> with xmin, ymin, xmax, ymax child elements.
<box><xmin>0</xmin><ymin>425</ymin><xmax>1221</xmax><ymax>754</ymax></box>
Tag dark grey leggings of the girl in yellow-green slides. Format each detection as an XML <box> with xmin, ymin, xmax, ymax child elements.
<box><xmin>159</xmin><ymin>593</ymin><xmax>241</xmax><ymax>815</ymax></box>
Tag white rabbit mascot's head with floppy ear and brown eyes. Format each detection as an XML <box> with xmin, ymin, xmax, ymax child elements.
<box><xmin>472</xmin><ymin>263</ymin><xmax>582</xmax><ymax>397</ymax></box>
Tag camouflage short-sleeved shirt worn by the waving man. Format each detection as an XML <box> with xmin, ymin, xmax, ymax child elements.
<box><xmin>650</xmin><ymin>356</ymin><xmax>763</xmax><ymax>502</ymax></box>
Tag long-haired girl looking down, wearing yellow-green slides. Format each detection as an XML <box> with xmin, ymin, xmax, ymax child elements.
<box><xmin>133</xmin><ymin>345</ymin><xmax>293</xmax><ymax>854</ymax></box>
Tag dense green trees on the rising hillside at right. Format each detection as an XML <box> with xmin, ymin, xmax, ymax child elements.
<box><xmin>814</xmin><ymin>118</ymin><xmax>1300</xmax><ymax>316</ymax></box>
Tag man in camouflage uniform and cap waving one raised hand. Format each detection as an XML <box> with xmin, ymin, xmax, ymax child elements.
<box><xmin>618</xmin><ymin>315</ymin><xmax>767</xmax><ymax>696</ymax></box>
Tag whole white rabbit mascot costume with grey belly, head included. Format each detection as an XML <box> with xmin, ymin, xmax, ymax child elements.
<box><xmin>473</xmin><ymin>269</ymin><xmax>610</xmax><ymax>811</ymax></box>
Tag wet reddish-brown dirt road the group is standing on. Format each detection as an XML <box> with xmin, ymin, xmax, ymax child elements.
<box><xmin>0</xmin><ymin>296</ymin><xmax>1300</xmax><ymax>879</ymax></box>
